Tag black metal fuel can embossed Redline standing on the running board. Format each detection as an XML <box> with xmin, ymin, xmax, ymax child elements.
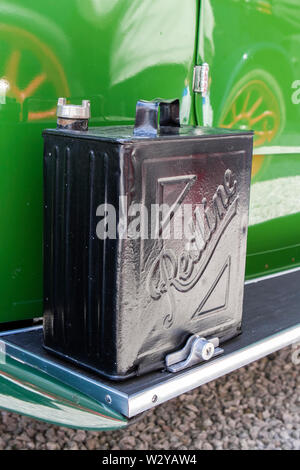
<box><xmin>43</xmin><ymin>101</ymin><xmax>253</xmax><ymax>380</ymax></box>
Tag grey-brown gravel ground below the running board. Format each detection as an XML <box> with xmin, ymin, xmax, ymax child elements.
<box><xmin>0</xmin><ymin>348</ymin><xmax>300</xmax><ymax>450</ymax></box>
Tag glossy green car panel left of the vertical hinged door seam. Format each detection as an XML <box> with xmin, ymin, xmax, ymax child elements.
<box><xmin>0</xmin><ymin>0</ymin><xmax>197</xmax><ymax>321</ymax></box>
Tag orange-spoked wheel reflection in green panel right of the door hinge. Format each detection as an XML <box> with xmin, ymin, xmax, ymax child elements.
<box><xmin>219</xmin><ymin>70</ymin><xmax>285</xmax><ymax>176</ymax></box>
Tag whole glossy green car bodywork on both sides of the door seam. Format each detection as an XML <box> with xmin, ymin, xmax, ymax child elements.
<box><xmin>0</xmin><ymin>0</ymin><xmax>300</xmax><ymax>429</ymax></box>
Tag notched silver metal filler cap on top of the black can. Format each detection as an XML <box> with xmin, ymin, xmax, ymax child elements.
<box><xmin>56</xmin><ymin>98</ymin><xmax>91</xmax><ymax>130</ymax></box>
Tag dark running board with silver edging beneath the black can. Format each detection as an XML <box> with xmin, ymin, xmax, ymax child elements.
<box><xmin>0</xmin><ymin>269</ymin><xmax>300</xmax><ymax>418</ymax></box>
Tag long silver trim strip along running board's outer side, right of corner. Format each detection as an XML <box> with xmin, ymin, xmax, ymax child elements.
<box><xmin>128</xmin><ymin>323</ymin><xmax>300</xmax><ymax>418</ymax></box>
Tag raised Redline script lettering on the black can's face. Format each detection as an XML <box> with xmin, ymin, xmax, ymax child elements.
<box><xmin>148</xmin><ymin>169</ymin><xmax>238</xmax><ymax>328</ymax></box>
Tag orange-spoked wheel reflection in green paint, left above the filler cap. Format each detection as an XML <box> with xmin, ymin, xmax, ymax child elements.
<box><xmin>0</xmin><ymin>24</ymin><xmax>69</xmax><ymax>121</ymax></box>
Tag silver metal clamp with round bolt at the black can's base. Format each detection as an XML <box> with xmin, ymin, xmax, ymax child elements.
<box><xmin>166</xmin><ymin>334</ymin><xmax>224</xmax><ymax>372</ymax></box>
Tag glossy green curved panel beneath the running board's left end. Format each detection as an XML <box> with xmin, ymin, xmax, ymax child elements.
<box><xmin>0</xmin><ymin>354</ymin><xmax>127</xmax><ymax>430</ymax></box>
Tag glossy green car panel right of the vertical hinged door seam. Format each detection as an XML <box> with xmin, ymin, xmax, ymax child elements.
<box><xmin>195</xmin><ymin>0</ymin><xmax>300</xmax><ymax>278</ymax></box>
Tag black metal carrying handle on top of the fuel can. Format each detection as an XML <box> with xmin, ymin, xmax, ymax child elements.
<box><xmin>133</xmin><ymin>99</ymin><xmax>180</xmax><ymax>137</ymax></box>
